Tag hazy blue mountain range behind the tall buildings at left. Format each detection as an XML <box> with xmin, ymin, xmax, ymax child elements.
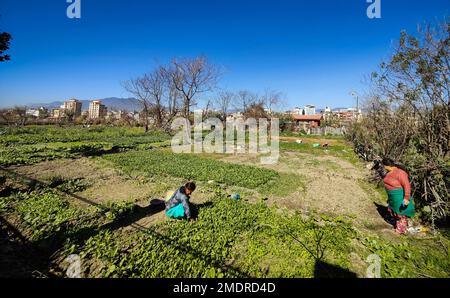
<box><xmin>27</xmin><ymin>97</ymin><xmax>141</xmax><ymax>112</ymax></box>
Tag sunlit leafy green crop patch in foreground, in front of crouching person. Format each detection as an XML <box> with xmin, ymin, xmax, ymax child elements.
<box><xmin>67</xmin><ymin>191</ymin><xmax>450</xmax><ymax>277</ymax></box>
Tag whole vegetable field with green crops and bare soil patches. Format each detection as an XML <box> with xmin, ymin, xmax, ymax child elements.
<box><xmin>0</xmin><ymin>127</ymin><xmax>450</xmax><ymax>277</ymax></box>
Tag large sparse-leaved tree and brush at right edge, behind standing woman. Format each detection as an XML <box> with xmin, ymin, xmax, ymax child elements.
<box><xmin>353</xmin><ymin>19</ymin><xmax>450</xmax><ymax>222</ymax></box>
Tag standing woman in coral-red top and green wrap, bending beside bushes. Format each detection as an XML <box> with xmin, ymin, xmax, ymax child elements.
<box><xmin>382</xmin><ymin>158</ymin><xmax>415</xmax><ymax>234</ymax></box>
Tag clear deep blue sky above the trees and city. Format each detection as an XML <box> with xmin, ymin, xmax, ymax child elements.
<box><xmin>0</xmin><ymin>0</ymin><xmax>450</xmax><ymax>108</ymax></box>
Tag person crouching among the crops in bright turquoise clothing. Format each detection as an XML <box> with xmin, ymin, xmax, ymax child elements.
<box><xmin>166</xmin><ymin>182</ymin><xmax>196</xmax><ymax>220</ymax></box>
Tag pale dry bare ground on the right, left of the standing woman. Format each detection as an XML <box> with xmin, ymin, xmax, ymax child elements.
<box><xmin>221</xmin><ymin>152</ymin><xmax>390</xmax><ymax>230</ymax></box>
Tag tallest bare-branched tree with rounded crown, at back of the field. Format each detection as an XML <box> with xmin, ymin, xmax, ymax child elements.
<box><xmin>164</xmin><ymin>56</ymin><xmax>220</xmax><ymax>118</ymax></box>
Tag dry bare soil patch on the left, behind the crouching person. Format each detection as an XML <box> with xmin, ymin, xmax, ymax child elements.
<box><xmin>8</xmin><ymin>158</ymin><xmax>213</xmax><ymax>229</ymax></box>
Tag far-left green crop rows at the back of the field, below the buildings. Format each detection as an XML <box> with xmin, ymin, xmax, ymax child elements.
<box><xmin>0</xmin><ymin>126</ymin><xmax>170</xmax><ymax>166</ymax></box>
